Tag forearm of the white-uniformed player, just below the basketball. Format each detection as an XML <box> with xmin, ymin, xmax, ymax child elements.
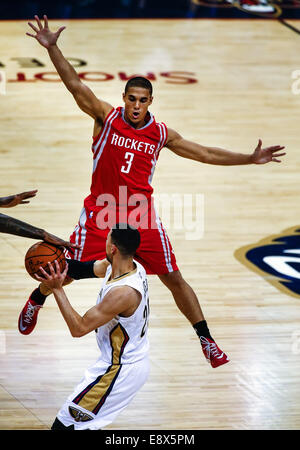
<box><xmin>52</xmin><ymin>288</ymin><xmax>85</xmax><ymax>337</ymax></box>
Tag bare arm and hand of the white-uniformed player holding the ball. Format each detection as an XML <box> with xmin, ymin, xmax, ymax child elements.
<box><xmin>35</xmin><ymin>261</ymin><xmax>141</xmax><ymax>337</ymax></box>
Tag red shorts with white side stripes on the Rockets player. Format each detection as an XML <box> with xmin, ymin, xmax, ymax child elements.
<box><xmin>69</xmin><ymin>207</ymin><xmax>178</xmax><ymax>275</ymax></box>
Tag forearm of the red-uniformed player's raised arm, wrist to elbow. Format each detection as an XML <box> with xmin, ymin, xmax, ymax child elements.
<box><xmin>48</xmin><ymin>45</ymin><xmax>81</xmax><ymax>92</ymax></box>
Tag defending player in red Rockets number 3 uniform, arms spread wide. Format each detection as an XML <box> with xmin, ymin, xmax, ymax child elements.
<box><xmin>21</xmin><ymin>16</ymin><xmax>285</xmax><ymax>367</ymax></box>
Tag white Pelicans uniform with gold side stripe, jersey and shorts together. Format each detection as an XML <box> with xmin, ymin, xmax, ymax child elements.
<box><xmin>57</xmin><ymin>260</ymin><xmax>150</xmax><ymax>430</ymax></box>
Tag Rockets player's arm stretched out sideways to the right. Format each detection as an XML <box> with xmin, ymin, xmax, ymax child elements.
<box><xmin>166</xmin><ymin>129</ymin><xmax>285</xmax><ymax>166</ymax></box>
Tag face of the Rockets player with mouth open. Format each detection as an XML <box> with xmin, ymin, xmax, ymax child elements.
<box><xmin>123</xmin><ymin>87</ymin><xmax>153</xmax><ymax>128</ymax></box>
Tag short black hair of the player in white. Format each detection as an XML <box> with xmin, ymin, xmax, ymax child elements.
<box><xmin>111</xmin><ymin>223</ymin><xmax>141</xmax><ymax>256</ymax></box>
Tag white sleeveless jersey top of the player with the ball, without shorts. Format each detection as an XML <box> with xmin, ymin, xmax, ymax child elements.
<box><xmin>96</xmin><ymin>260</ymin><xmax>149</xmax><ymax>365</ymax></box>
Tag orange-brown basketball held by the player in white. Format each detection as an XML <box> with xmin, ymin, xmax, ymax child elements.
<box><xmin>25</xmin><ymin>242</ymin><xmax>66</xmax><ymax>279</ymax></box>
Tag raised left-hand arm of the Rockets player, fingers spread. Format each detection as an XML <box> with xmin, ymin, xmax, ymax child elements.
<box><xmin>26</xmin><ymin>16</ymin><xmax>112</xmax><ymax>122</ymax></box>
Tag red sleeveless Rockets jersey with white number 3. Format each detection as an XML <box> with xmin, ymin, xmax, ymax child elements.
<box><xmin>84</xmin><ymin>107</ymin><xmax>168</xmax><ymax>212</ymax></box>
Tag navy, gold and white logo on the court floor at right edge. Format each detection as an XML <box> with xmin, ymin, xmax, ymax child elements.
<box><xmin>234</xmin><ymin>225</ymin><xmax>300</xmax><ymax>298</ymax></box>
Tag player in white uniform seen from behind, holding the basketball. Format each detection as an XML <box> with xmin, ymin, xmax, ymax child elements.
<box><xmin>36</xmin><ymin>224</ymin><xmax>149</xmax><ymax>430</ymax></box>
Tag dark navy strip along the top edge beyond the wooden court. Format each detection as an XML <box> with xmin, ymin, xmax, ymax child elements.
<box><xmin>0</xmin><ymin>0</ymin><xmax>300</xmax><ymax>20</ymax></box>
